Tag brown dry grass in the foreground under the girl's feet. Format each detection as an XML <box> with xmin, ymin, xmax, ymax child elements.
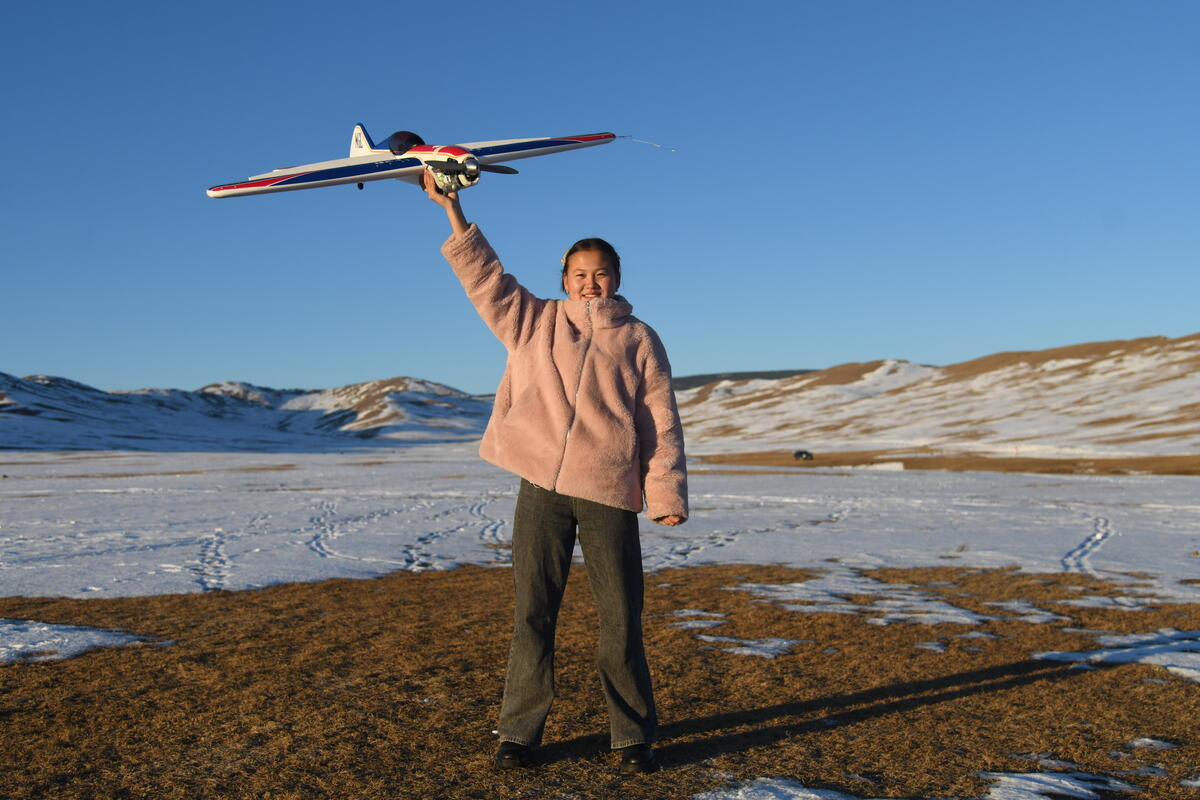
<box><xmin>0</xmin><ymin>565</ymin><xmax>1200</xmax><ymax>800</ymax></box>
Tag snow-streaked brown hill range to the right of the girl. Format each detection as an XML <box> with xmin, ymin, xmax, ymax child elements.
<box><xmin>678</xmin><ymin>333</ymin><xmax>1200</xmax><ymax>457</ymax></box>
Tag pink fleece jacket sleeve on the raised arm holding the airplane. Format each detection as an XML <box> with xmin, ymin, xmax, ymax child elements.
<box><xmin>442</xmin><ymin>223</ymin><xmax>547</xmax><ymax>350</ymax></box>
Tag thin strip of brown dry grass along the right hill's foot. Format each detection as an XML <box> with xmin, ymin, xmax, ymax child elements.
<box><xmin>694</xmin><ymin>447</ymin><xmax>1200</xmax><ymax>475</ymax></box>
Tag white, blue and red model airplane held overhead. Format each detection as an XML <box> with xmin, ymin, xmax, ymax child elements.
<box><xmin>209</xmin><ymin>124</ymin><xmax>617</xmax><ymax>197</ymax></box>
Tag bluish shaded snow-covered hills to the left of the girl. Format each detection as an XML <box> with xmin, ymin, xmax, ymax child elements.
<box><xmin>0</xmin><ymin>373</ymin><xmax>491</xmax><ymax>451</ymax></box>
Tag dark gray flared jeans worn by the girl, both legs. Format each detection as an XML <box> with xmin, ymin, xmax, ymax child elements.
<box><xmin>499</xmin><ymin>481</ymin><xmax>658</xmax><ymax>748</ymax></box>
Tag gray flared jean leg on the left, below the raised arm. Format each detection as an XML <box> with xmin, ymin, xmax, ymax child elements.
<box><xmin>499</xmin><ymin>481</ymin><xmax>576</xmax><ymax>746</ymax></box>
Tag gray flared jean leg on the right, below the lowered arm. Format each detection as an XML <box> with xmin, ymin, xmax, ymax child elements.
<box><xmin>572</xmin><ymin>499</ymin><xmax>658</xmax><ymax>750</ymax></box>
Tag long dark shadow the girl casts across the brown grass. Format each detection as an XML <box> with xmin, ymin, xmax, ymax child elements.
<box><xmin>542</xmin><ymin>658</ymin><xmax>1105</xmax><ymax>766</ymax></box>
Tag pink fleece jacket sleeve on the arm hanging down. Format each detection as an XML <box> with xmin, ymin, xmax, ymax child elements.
<box><xmin>634</xmin><ymin>329</ymin><xmax>688</xmax><ymax>519</ymax></box>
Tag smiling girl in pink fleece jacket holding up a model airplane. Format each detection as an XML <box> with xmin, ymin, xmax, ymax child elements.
<box><xmin>422</xmin><ymin>169</ymin><xmax>688</xmax><ymax>772</ymax></box>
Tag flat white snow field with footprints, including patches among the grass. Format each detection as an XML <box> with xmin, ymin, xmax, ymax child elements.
<box><xmin>0</xmin><ymin>441</ymin><xmax>1200</xmax><ymax>800</ymax></box>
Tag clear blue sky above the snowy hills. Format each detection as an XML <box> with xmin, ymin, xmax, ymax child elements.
<box><xmin>0</xmin><ymin>0</ymin><xmax>1200</xmax><ymax>392</ymax></box>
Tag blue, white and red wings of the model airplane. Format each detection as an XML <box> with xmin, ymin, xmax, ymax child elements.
<box><xmin>208</xmin><ymin>133</ymin><xmax>617</xmax><ymax>197</ymax></box>
